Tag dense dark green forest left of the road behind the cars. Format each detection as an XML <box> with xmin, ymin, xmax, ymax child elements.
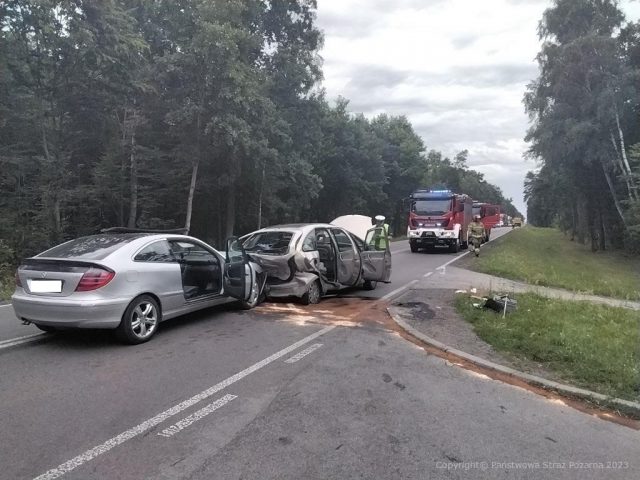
<box><xmin>0</xmin><ymin>0</ymin><xmax>520</xmax><ymax>280</ymax></box>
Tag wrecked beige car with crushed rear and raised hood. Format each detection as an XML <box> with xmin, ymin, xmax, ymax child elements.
<box><xmin>241</xmin><ymin>215</ymin><xmax>391</xmax><ymax>304</ymax></box>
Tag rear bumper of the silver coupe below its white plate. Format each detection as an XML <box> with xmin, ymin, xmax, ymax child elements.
<box><xmin>11</xmin><ymin>292</ymin><xmax>131</xmax><ymax>328</ymax></box>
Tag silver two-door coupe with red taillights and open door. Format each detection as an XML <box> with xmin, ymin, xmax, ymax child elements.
<box><xmin>11</xmin><ymin>229</ymin><xmax>264</xmax><ymax>344</ymax></box>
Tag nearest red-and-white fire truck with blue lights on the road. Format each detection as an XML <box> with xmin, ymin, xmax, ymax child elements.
<box><xmin>407</xmin><ymin>189</ymin><xmax>473</xmax><ymax>252</ymax></box>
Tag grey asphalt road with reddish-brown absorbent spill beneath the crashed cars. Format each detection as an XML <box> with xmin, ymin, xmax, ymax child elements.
<box><xmin>0</xmin><ymin>232</ymin><xmax>640</xmax><ymax>480</ymax></box>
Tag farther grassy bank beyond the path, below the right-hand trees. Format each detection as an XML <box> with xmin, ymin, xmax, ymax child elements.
<box><xmin>469</xmin><ymin>226</ymin><xmax>640</xmax><ymax>300</ymax></box>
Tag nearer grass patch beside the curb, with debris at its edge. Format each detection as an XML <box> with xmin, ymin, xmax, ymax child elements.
<box><xmin>456</xmin><ymin>293</ymin><xmax>640</xmax><ymax>401</ymax></box>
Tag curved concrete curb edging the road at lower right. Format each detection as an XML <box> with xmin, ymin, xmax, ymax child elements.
<box><xmin>387</xmin><ymin>307</ymin><xmax>640</xmax><ymax>416</ymax></box>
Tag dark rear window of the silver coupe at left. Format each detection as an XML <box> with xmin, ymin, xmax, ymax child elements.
<box><xmin>37</xmin><ymin>234</ymin><xmax>142</xmax><ymax>260</ymax></box>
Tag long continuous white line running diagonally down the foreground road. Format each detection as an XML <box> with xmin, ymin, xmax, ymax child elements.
<box><xmin>35</xmin><ymin>325</ymin><xmax>335</xmax><ymax>480</ymax></box>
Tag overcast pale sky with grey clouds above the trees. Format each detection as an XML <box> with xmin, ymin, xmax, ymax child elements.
<box><xmin>317</xmin><ymin>0</ymin><xmax>640</xmax><ymax>214</ymax></box>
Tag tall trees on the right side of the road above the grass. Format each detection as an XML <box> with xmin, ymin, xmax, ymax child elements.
<box><xmin>524</xmin><ymin>0</ymin><xmax>640</xmax><ymax>252</ymax></box>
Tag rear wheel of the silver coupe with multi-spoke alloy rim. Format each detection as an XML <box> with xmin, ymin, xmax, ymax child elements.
<box><xmin>116</xmin><ymin>295</ymin><xmax>162</xmax><ymax>345</ymax></box>
